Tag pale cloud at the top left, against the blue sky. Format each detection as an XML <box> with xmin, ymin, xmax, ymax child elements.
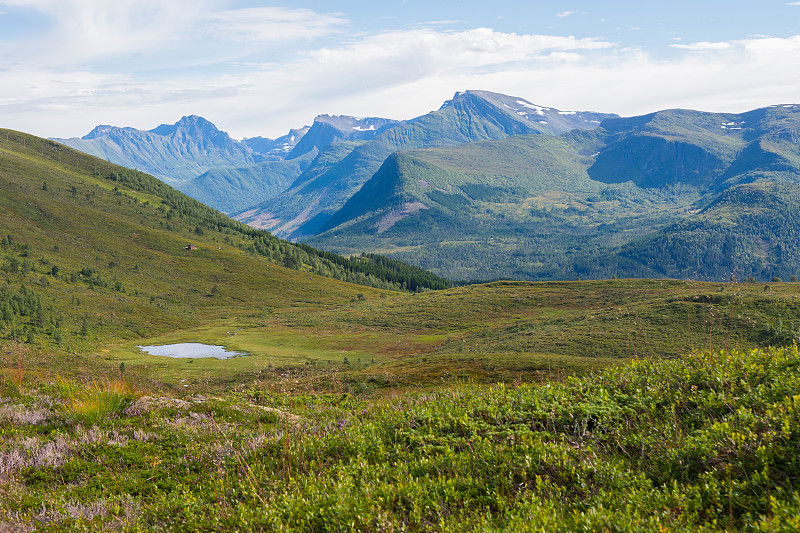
<box><xmin>0</xmin><ymin>0</ymin><xmax>348</xmax><ymax>64</ymax></box>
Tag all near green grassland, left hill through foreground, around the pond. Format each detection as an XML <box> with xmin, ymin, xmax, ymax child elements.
<box><xmin>0</xmin><ymin>128</ymin><xmax>800</xmax><ymax>532</ymax></box>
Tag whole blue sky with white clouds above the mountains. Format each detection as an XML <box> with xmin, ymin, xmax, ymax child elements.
<box><xmin>0</xmin><ymin>0</ymin><xmax>800</xmax><ymax>138</ymax></box>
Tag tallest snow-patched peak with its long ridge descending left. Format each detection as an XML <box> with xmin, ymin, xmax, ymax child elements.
<box><xmin>237</xmin><ymin>91</ymin><xmax>612</xmax><ymax>239</ymax></box>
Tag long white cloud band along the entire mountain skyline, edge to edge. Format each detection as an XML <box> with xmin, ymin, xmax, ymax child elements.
<box><xmin>0</xmin><ymin>14</ymin><xmax>800</xmax><ymax>141</ymax></box>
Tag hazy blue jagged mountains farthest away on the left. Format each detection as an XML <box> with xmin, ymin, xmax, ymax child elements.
<box><xmin>54</xmin><ymin>115</ymin><xmax>398</xmax><ymax>213</ymax></box>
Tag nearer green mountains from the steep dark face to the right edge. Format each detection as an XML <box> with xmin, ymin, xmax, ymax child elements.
<box><xmin>307</xmin><ymin>101</ymin><xmax>800</xmax><ymax>279</ymax></box>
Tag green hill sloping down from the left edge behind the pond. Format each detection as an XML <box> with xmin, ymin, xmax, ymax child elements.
<box><xmin>0</xmin><ymin>130</ymin><xmax>454</xmax><ymax>348</ymax></box>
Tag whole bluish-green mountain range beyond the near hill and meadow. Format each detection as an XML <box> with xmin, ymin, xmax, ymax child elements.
<box><xmin>51</xmin><ymin>91</ymin><xmax>800</xmax><ymax>280</ymax></box>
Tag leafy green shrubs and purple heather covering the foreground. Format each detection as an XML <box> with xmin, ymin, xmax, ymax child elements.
<box><xmin>0</xmin><ymin>346</ymin><xmax>800</xmax><ymax>532</ymax></box>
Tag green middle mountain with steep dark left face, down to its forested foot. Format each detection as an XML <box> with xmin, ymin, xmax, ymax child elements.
<box><xmin>306</xmin><ymin>135</ymin><xmax>700</xmax><ymax>280</ymax></box>
